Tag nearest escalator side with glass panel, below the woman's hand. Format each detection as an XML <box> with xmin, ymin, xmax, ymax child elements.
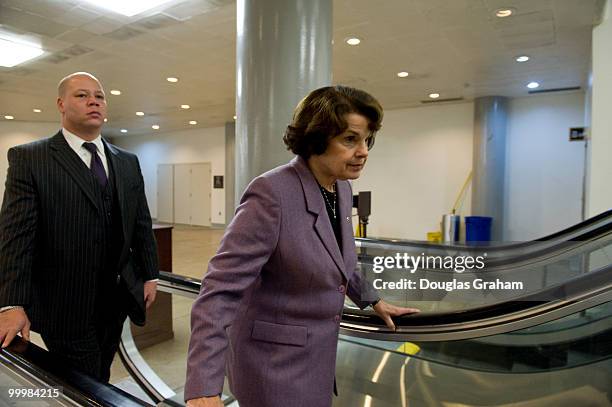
<box><xmin>123</xmin><ymin>266</ymin><xmax>612</xmax><ymax>407</ymax></box>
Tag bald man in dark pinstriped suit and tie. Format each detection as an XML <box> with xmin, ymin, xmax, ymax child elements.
<box><xmin>0</xmin><ymin>72</ymin><xmax>158</xmax><ymax>381</ymax></box>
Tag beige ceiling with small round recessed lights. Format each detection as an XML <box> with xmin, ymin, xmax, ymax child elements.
<box><xmin>0</xmin><ymin>0</ymin><xmax>604</xmax><ymax>136</ymax></box>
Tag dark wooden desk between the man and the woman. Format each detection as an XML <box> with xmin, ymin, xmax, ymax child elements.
<box><xmin>132</xmin><ymin>225</ymin><xmax>174</xmax><ymax>349</ymax></box>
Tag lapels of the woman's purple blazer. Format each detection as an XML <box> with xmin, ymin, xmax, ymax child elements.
<box><xmin>291</xmin><ymin>156</ymin><xmax>352</xmax><ymax>279</ymax></box>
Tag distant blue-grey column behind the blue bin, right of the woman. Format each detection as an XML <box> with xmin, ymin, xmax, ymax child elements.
<box><xmin>472</xmin><ymin>96</ymin><xmax>508</xmax><ymax>241</ymax></box>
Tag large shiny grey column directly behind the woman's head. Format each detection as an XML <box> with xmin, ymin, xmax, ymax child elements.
<box><xmin>235</xmin><ymin>0</ymin><xmax>332</xmax><ymax>201</ymax></box>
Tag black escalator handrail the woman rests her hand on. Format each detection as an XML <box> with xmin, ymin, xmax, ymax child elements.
<box><xmin>159</xmin><ymin>265</ymin><xmax>612</xmax><ymax>341</ymax></box>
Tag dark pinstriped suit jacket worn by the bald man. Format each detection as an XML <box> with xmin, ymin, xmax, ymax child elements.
<box><xmin>0</xmin><ymin>131</ymin><xmax>158</xmax><ymax>335</ymax></box>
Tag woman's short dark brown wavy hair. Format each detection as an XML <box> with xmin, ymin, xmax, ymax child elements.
<box><xmin>283</xmin><ymin>85</ymin><xmax>383</xmax><ymax>159</ymax></box>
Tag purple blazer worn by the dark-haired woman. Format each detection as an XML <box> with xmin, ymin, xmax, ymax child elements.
<box><xmin>185</xmin><ymin>157</ymin><xmax>376</xmax><ymax>407</ymax></box>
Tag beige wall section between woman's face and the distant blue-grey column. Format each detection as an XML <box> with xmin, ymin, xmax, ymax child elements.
<box><xmin>353</xmin><ymin>103</ymin><xmax>474</xmax><ymax>240</ymax></box>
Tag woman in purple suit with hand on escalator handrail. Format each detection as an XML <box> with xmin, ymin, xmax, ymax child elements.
<box><xmin>185</xmin><ymin>86</ymin><xmax>418</xmax><ymax>407</ymax></box>
